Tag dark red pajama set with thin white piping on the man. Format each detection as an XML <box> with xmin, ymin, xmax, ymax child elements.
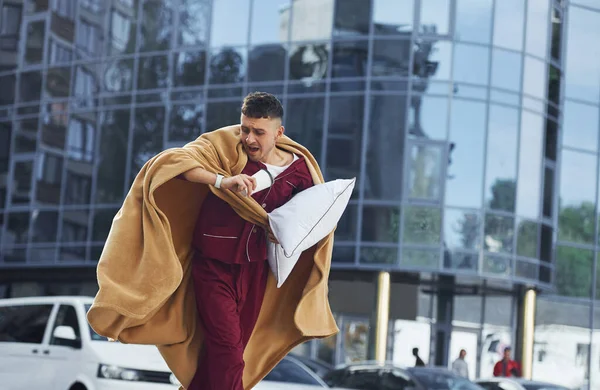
<box><xmin>188</xmin><ymin>158</ymin><xmax>313</xmax><ymax>390</ymax></box>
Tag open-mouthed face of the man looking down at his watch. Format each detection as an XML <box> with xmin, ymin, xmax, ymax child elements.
<box><xmin>240</xmin><ymin>114</ymin><xmax>284</xmax><ymax>162</ymax></box>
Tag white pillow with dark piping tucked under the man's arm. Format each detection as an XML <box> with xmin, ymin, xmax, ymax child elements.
<box><xmin>267</xmin><ymin>178</ymin><xmax>356</xmax><ymax>288</ymax></box>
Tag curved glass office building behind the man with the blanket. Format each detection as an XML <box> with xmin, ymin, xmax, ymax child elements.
<box><xmin>0</xmin><ymin>0</ymin><xmax>600</xmax><ymax>389</ymax></box>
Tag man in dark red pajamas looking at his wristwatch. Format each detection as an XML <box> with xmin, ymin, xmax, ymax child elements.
<box><xmin>183</xmin><ymin>92</ymin><xmax>313</xmax><ymax>390</ymax></box>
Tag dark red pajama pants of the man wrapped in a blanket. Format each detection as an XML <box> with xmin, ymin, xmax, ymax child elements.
<box><xmin>188</xmin><ymin>257</ymin><xmax>269</xmax><ymax>390</ymax></box>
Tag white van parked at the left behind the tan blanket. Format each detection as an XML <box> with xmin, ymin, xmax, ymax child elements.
<box><xmin>0</xmin><ymin>297</ymin><xmax>178</xmax><ymax>390</ymax></box>
